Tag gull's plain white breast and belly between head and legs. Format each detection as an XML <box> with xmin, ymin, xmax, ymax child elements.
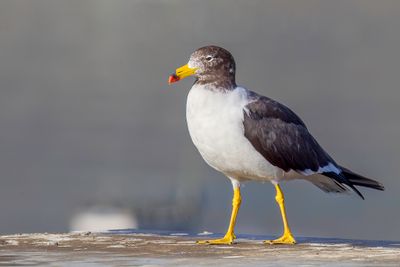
<box><xmin>186</xmin><ymin>85</ymin><xmax>284</xmax><ymax>181</ymax></box>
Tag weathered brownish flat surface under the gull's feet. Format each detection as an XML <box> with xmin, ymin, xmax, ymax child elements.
<box><xmin>0</xmin><ymin>230</ymin><xmax>400</xmax><ymax>266</ymax></box>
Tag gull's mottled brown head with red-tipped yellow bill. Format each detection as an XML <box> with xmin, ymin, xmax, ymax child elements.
<box><xmin>168</xmin><ymin>45</ymin><xmax>236</xmax><ymax>89</ymax></box>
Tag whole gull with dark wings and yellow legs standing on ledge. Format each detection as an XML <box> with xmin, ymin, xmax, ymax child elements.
<box><xmin>169</xmin><ymin>46</ymin><xmax>384</xmax><ymax>244</ymax></box>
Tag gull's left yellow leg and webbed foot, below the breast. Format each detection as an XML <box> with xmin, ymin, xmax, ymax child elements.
<box><xmin>197</xmin><ymin>186</ymin><xmax>242</xmax><ymax>245</ymax></box>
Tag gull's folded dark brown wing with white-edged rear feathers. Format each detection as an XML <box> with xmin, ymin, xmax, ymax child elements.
<box><xmin>243</xmin><ymin>92</ymin><xmax>366</xmax><ymax>198</ymax></box>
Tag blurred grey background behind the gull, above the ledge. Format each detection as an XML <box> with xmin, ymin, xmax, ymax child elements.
<box><xmin>0</xmin><ymin>0</ymin><xmax>400</xmax><ymax>240</ymax></box>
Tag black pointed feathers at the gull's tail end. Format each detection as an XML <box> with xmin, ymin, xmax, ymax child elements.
<box><xmin>322</xmin><ymin>167</ymin><xmax>385</xmax><ymax>199</ymax></box>
